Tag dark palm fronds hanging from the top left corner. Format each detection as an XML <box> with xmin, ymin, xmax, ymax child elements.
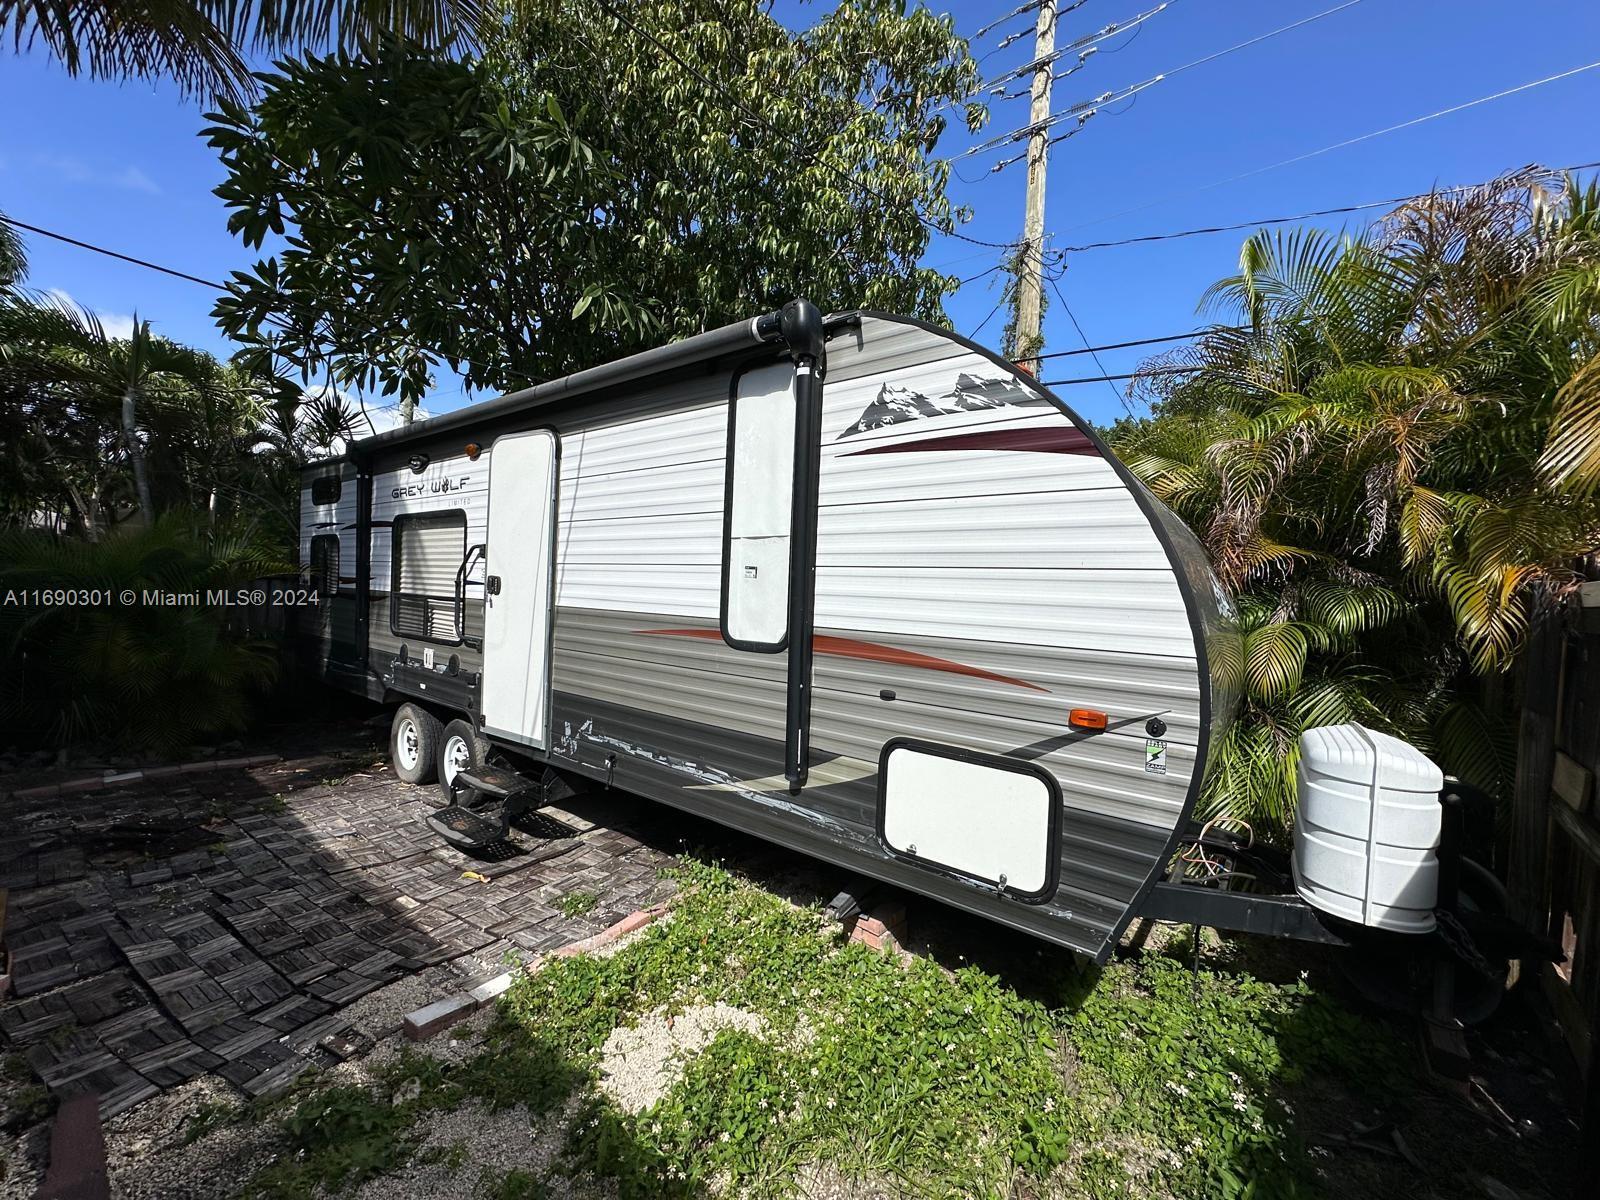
<box><xmin>0</xmin><ymin>0</ymin><xmax>498</xmax><ymax>101</ymax></box>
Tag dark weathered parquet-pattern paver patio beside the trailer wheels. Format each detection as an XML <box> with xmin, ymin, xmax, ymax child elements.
<box><xmin>0</xmin><ymin>739</ymin><xmax>674</xmax><ymax>1118</ymax></box>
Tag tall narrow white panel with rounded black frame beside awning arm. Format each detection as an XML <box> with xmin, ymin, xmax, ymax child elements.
<box><xmin>722</xmin><ymin>363</ymin><xmax>795</xmax><ymax>651</ymax></box>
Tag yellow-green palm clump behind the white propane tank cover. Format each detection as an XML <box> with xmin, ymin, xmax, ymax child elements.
<box><xmin>1114</xmin><ymin>171</ymin><xmax>1600</xmax><ymax>829</ymax></box>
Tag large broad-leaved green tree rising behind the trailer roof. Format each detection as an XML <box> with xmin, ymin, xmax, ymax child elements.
<box><xmin>208</xmin><ymin>0</ymin><xmax>984</xmax><ymax>406</ymax></box>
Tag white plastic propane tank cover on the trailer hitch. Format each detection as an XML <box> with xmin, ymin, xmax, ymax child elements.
<box><xmin>1291</xmin><ymin>723</ymin><xmax>1445</xmax><ymax>933</ymax></box>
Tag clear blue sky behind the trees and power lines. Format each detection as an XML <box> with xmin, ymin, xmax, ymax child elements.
<box><xmin>0</xmin><ymin>0</ymin><xmax>1600</xmax><ymax>422</ymax></box>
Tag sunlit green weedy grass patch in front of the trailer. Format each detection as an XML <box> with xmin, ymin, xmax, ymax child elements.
<box><xmin>232</xmin><ymin>864</ymin><xmax>1403</xmax><ymax>1200</ymax></box>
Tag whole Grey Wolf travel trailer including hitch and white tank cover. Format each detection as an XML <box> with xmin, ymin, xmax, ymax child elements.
<box><xmin>301</xmin><ymin>301</ymin><xmax>1536</xmax><ymax>1004</ymax></box>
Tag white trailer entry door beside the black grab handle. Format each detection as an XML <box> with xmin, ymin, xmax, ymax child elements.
<box><xmin>482</xmin><ymin>429</ymin><xmax>557</xmax><ymax>749</ymax></box>
